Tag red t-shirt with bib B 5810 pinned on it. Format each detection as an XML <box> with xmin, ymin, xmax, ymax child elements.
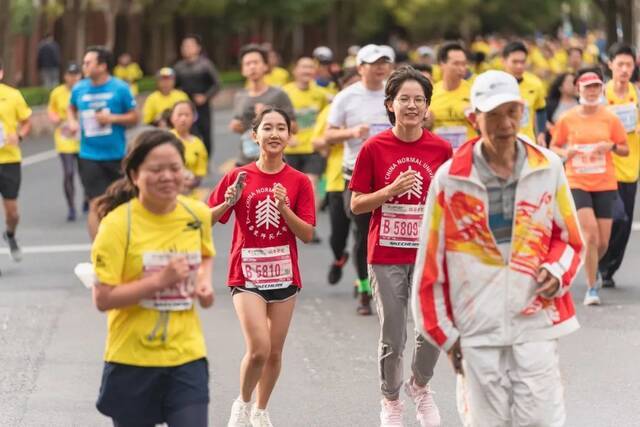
<box><xmin>209</xmin><ymin>163</ymin><xmax>316</xmax><ymax>289</ymax></box>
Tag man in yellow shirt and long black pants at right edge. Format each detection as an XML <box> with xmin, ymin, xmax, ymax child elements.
<box><xmin>598</xmin><ymin>43</ymin><xmax>640</xmax><ymax>287</ymax></box>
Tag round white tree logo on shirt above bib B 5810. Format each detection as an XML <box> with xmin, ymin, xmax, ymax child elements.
<box><xmin>245</xmin><ymin>187</ymin><xmax>289</xmax><ymax>240</ymax></box>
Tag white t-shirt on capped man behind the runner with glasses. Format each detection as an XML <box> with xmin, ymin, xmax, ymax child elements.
<box><xmin>328</xmin><ymin>82</ymin><xmax>391</xmax><ymax>179</ymax></box>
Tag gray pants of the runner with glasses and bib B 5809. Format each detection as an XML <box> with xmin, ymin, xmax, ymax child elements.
<box><xmin>369</xmin><ymin>264</ymin><xmax>440</xmax><ymax>400</ymax></box>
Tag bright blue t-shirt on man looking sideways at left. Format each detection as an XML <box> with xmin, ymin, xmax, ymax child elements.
<box><xmin>70</xmin><ymin>77</ymin><xmax>136</xmax><ymax>160</ymax></box>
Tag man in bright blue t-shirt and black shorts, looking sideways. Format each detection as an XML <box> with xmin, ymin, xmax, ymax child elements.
<box><xmin>69</xmin><ymin>46</ymin><xmax>138</xmax><ymax>201</ymax></box>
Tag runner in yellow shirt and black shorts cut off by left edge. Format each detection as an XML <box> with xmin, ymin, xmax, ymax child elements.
<box><xmin>0</xmin><ymin>60</ymin><xmax>31</xmax><ymax>261</ymax></box>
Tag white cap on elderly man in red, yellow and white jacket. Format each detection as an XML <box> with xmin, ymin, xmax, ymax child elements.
<box><xmin>471</xmin><ymin>70</ymin><xmax>523</xmax><ymax>113</ymax></box>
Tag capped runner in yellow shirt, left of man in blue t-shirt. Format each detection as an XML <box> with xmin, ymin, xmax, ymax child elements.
<box><xmin>47</xmin><ymin>64</ymin><xmax>82</xmax><ymax>221</ymax></box>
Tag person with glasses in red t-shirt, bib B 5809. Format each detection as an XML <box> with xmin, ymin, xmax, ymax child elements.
<box><xmin>349</xmin><ymin>66</ymin><xmax>452</xmax><ymax>426</ymax></box>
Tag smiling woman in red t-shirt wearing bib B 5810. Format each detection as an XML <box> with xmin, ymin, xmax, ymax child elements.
<box><xmin>209</xmin><ymin>107</ymin><xmax>316</xmax><ymax>426</ymax></box>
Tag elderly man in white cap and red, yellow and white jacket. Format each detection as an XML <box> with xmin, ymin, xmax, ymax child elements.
<box><xmin>412</xmin><ymin>71</ymin><xmax>584</xmax><ymax>427</ymax></box>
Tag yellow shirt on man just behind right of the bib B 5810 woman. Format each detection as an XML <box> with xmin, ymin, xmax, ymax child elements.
<box><xmin>282</xmin><ymin>82</ymin><xmax>329</xmax><ymax>154</ymax></box>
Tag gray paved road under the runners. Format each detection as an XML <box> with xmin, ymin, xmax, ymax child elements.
<box><xmin>0</xmin><ymin>113</ymin><xmax>640</xmax><ymax>427</ymax></box>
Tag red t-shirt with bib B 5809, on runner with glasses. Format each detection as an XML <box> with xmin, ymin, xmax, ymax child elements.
<box><xmin>349</xmin><ymin>129</ymin><xmax>453</xmax><ymax>264</ymax></box>
